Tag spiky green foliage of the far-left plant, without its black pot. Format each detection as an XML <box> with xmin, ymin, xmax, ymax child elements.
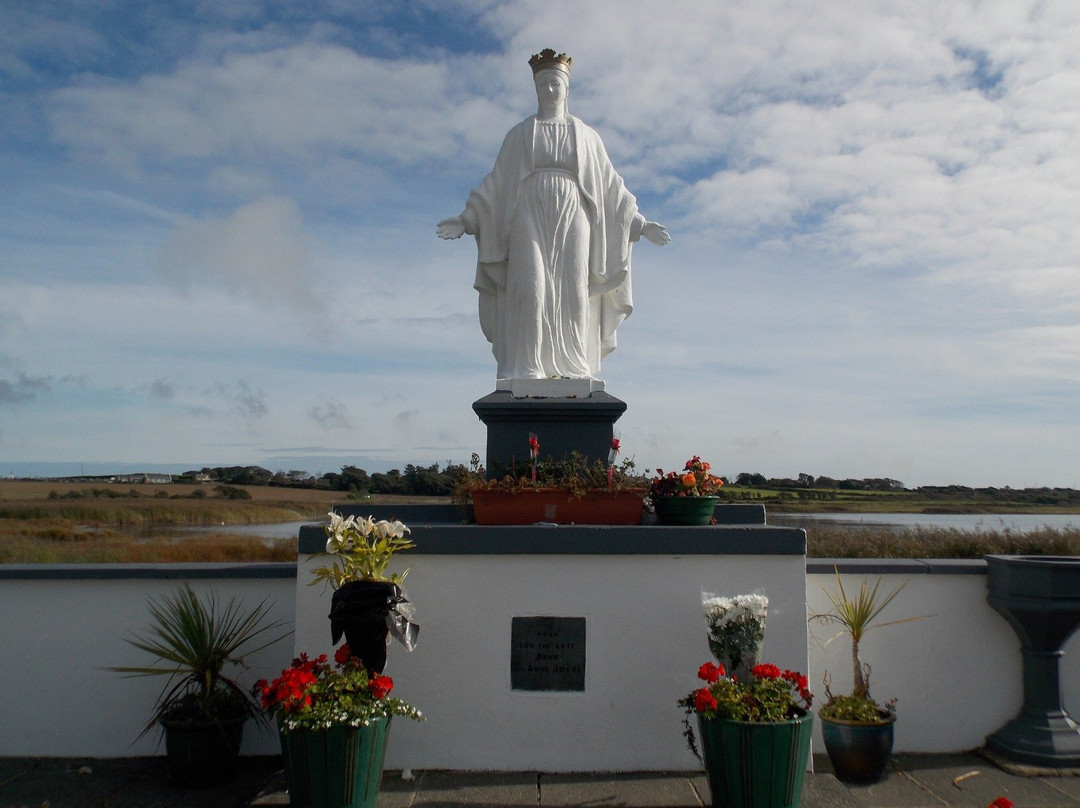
<box><xmin>109</xmin><ymin>583</ymin><xmax>292</xmax><ymax>738</ymax></box>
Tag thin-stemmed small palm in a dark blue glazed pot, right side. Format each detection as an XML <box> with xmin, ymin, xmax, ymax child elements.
<box><xmin>811</xmin><ymin>570</ymin><xmax>922</xmax><ymax>783</ymax></box>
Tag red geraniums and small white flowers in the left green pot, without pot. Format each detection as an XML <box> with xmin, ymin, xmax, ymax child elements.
<box><xmin>255</xmin><ymin>643</ymin><xmax>422</xmax><ymax>732</ymax></box>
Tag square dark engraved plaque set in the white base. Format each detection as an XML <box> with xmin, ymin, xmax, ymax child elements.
<box><xmin>510</xmin><ymin>617</ymin><xmax>585</xmax><ymax>691</ymax></box>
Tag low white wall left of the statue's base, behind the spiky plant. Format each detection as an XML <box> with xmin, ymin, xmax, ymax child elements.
<box><xmin>0</xmin><ymin>565</ymin><xmax>296</xmax><ymax>757</ymax></box>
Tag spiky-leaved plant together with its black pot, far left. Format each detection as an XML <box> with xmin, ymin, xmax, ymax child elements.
<box><xmin>110</xmin><ymin>583</ymin><xmax>292</xmax><ymax>786</ymax></box>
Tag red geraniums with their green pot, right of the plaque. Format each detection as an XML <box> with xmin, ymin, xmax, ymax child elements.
<box><xmin>678</xmin><ymin>662</ymin><xmax>813</xmax><ymax>808</ymax></box>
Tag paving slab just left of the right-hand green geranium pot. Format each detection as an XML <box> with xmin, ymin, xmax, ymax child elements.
<box><xmin>539</xmin><ymin>772</ymin><xmax>705</xmax><ymax>808</ymax></box>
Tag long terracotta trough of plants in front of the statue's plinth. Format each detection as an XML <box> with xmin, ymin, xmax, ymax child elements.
<box><xmin>455</xmin><ymin>445</ymin><xmax>646</xmax><ymax>525</ymax></box>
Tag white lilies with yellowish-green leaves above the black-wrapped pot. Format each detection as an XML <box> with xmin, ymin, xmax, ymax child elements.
<box><xmin>309</xmin><ymin>511</ymin><xmax>416</xmax><ymax>589</ymax></box>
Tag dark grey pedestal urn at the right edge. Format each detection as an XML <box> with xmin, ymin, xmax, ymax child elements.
<box><xmin>986</xmin><ymin>555</ymin><xmax>1080</xmax><ymax>769</ymax></box>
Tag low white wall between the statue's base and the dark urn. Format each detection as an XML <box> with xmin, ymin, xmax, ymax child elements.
<box><xmin>807</xmin><ymin>562</ymin><xmax>1080</xmax><ymax>752</ymax></box>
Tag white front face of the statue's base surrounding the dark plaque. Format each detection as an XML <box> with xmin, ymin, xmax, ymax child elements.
<box><xmin>296</xmin><ymin>548</ymin><xmax>807</xmax><ymax>771</ymax></box>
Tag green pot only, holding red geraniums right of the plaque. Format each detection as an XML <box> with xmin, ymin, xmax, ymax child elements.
<box><xmin>698</xmin><ymin>711</ymin><xmax>813</xmax><ymax>808</ymax></box>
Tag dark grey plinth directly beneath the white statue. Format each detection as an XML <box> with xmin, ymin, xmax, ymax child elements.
<box><xmin>473</xmin><ymin>390</ymin><xmax>626</xmax><ymax>475</ymax></box>
